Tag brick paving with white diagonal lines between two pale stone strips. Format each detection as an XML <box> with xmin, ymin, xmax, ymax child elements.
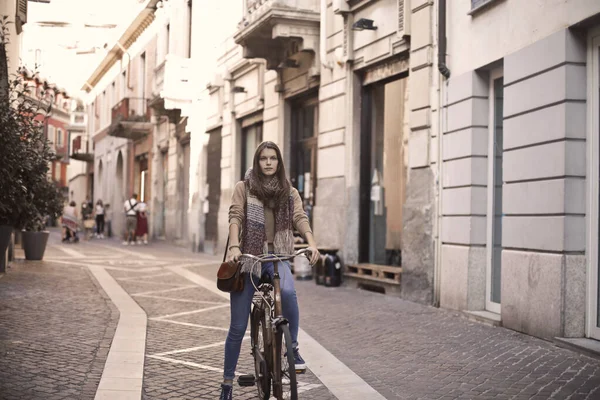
<box><xmin>109</xmin><ymin>262</ymin><xmax>335</xmax><ymax>400</ymax></box>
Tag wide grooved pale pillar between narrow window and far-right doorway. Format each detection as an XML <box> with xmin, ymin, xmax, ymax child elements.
<box><xmin>502</xmin><ymin>29</ymin><xmax>587</xmax><ymax>338</ymax></box>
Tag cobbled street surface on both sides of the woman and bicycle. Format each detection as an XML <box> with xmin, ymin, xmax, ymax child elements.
<box><xmin>0</xmin><ymin>234</ymin><xmax>600</xmax><ymax>400</ymax></box>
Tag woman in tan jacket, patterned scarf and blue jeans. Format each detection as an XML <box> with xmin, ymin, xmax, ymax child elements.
<box><xmin>220</xmin><ymin>142</ymin><xmax>319</xmax><ymax>400</ymax></box>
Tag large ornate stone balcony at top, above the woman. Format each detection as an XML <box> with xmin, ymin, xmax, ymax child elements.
<box><xmin>234</xmin><ymin>0</ymin><xmax>321</xmax><ymax>69</ymax></box>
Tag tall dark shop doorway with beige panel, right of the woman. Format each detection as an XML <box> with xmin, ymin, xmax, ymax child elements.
<box><xmin>359</xmin><ymin>79</ymin><xmax>406</xmax><ymax>266</ymax></box>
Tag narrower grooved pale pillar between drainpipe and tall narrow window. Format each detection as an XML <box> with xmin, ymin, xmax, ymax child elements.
<box><xmin>439</xmin><ymin>71</ymin><xmax>489</xmax><ymax>311</ymax></box>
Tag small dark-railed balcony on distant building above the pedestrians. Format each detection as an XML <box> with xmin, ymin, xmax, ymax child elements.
<box><xmin>108</xmin><ymin>97</ymin><xmax>153</xmax><ymax>140</ymax></box>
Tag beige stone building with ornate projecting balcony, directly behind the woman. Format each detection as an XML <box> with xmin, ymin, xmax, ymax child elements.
<box><xmin>194</xmin><ymin>0</ymin><xmax>437</xmax><ymax>302</ymax></box>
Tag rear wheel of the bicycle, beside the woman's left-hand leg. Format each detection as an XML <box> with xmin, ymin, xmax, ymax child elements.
<box><xmin>250</xmin><ymin>307</ymin><xmax>271</xmax><ymax>400</ymax></box>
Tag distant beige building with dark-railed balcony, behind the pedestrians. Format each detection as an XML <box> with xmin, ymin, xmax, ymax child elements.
<box><xmin>82</xmin><ymin>0</ymin><xmax>158</xmax><ymax>237</ymax></box>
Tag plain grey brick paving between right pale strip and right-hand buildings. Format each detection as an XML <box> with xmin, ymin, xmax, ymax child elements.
<box><xmin>296</xmin><ymin>282</ymin><xmax>600</xmax><ymax>400</ymax></box>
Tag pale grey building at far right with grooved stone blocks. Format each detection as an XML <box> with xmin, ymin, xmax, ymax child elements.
<box><xmin>438</xmin><ymin>0</ymin><xmax>600</xmax><ymax>339</ymax></box>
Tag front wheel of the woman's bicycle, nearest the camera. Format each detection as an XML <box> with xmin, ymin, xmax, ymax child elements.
<box><xmin>273</xmin><ymin>325</ymin><xmax>298</xmax><ymax>400</ymax></box>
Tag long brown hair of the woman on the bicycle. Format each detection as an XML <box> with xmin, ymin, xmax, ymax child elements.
<box><xmin>250</xmin><ymin>141</ymin><xmax>291</xmax><ymax>205</ymax></box>
